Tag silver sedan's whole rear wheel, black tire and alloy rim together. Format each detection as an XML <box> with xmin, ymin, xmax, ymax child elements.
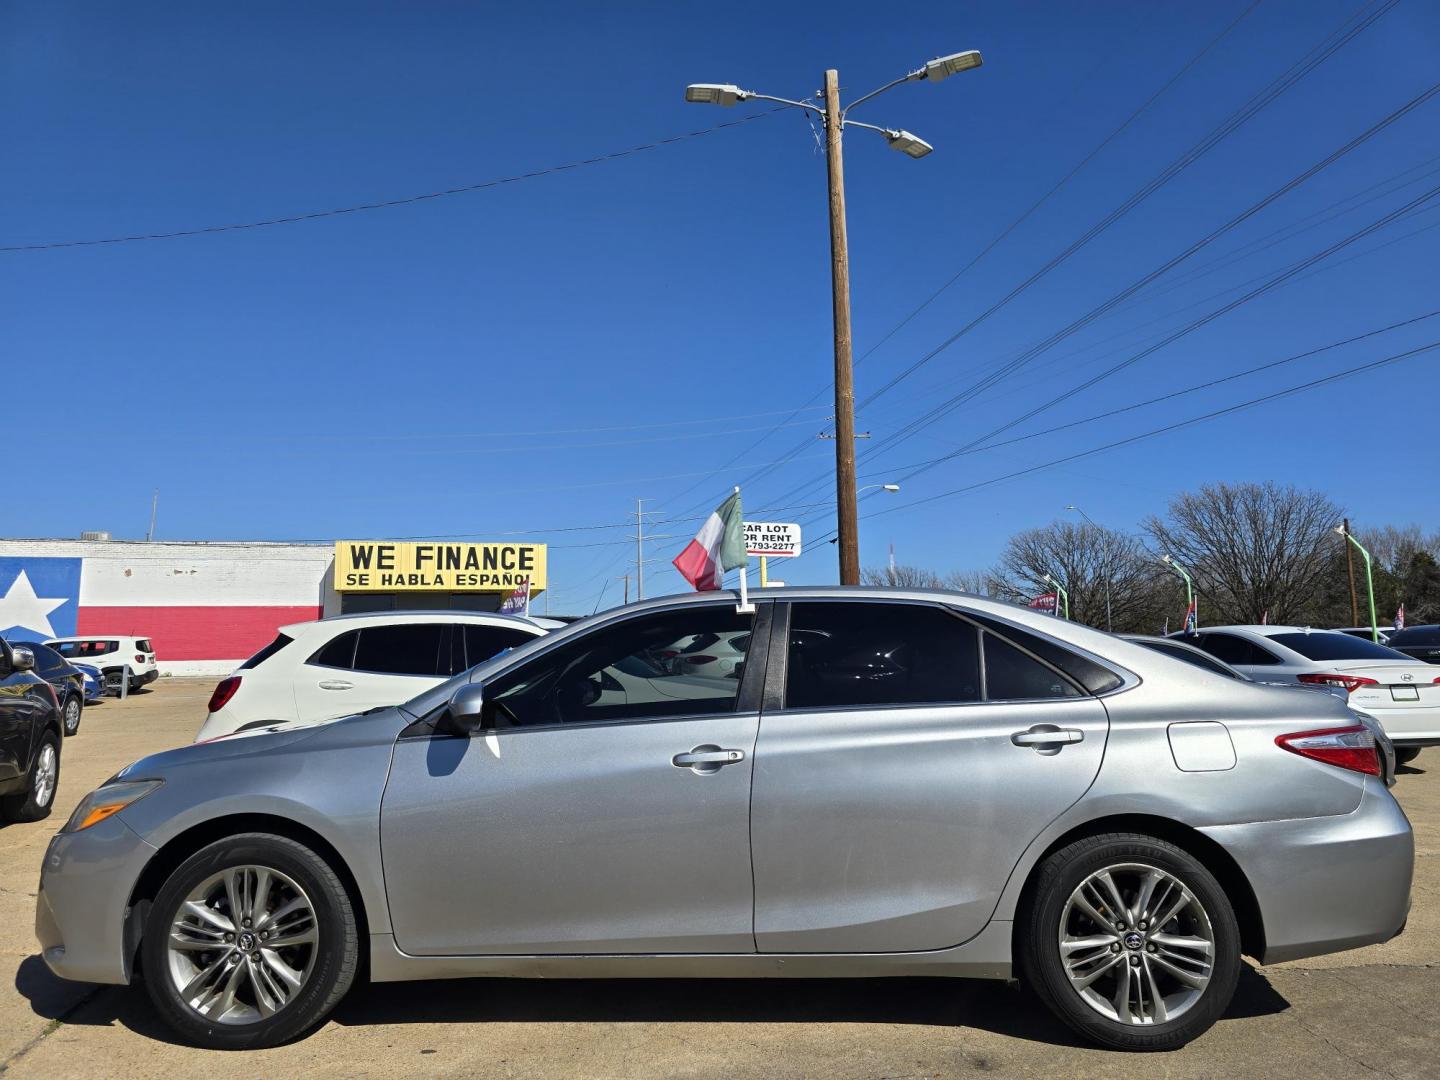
<box><xmin>1021</xmin><ymin>834</ymin><xmax>1240</xmax><ymax>1050</ymax></box>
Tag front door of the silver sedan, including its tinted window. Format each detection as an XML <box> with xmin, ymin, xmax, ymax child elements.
<box><xmin>380</xmin><ymin>600</ymin><xmax>769</xmax><ymax>955</ymax></box>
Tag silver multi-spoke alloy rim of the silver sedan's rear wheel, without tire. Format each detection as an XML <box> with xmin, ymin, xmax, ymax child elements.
<box><xmin>1058</xmin><ymin>863</ymin><xmax>1215</xmax><ymax>1025</ymax></box>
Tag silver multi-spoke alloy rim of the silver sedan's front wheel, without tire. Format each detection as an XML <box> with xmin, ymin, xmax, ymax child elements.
<box><xmin>167</xmin><ymin>865</ymin><xmax>320</xmax><ymax>1025</ymax></box>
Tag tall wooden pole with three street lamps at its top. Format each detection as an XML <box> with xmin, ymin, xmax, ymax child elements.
<box><xmin>685</xmin><ymin>49</ymin><xmax>984</xmax><ymax>585</ymax></box>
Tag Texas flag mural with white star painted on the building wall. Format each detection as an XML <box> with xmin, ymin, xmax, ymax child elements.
<box><xmin>0</xmin><ymin>556</ymin><xmax>323</xmax><ymax>670</ymax></box>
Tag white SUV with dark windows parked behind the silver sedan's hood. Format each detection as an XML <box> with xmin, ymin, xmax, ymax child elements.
<box><xmin>196</xmin><ymin>611</ymin><xmax>564</xmax><ymax>742</ymax></box>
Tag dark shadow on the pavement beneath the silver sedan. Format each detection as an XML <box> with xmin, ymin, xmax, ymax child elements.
<box><xmin>14</xmin><ymin>956</ymin><xmax>1290</xmax><ymax>1047</ymax></box>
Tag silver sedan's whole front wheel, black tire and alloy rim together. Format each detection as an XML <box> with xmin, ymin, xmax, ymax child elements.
<box><xmin>141</xmin><ymin>832</ymin><xmax>360</xmax><ymax>1050</ymax></box>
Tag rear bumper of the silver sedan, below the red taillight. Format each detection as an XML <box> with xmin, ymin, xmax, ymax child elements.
<box><xmin>1201</xmin><ymin>778</ymin><xmax>1416</xmax><ymax>963</ymax></box>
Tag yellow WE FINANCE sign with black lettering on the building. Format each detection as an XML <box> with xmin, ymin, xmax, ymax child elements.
<box><xmin>336</xmin><ymin>540</ymin><xmax>546</xmax><ymax>592</ymax></box>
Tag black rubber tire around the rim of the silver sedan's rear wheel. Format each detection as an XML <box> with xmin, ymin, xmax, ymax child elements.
<box><xmin>1020</xmin><ymin>832</ymin><xmax>1240</xmax><ymax>1050</ymax></box>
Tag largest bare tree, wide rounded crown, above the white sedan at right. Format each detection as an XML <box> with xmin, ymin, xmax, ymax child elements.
<box><xmin>1145</xmin><ymin>481</ymin><xmax>1344</xmax><ymax>624</ymax></box>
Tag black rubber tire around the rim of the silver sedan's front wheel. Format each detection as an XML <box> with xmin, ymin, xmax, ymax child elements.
<box><xmin>140</xmin><ymin>832</ymin><xmax>360</xmax><ymax>1050</ymax></box>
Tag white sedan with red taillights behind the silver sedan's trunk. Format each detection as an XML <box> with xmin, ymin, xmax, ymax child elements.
<box><xmin>1171</xmin><ymin>626</ymin><xmax>1440</xmax><ymax>763</ymax></box>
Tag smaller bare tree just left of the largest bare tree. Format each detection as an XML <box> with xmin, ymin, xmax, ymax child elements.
<box><xmin>994</xmin><ymin>521</ymin><xmax>1164</xmax><ymax>632</ymax></box>
